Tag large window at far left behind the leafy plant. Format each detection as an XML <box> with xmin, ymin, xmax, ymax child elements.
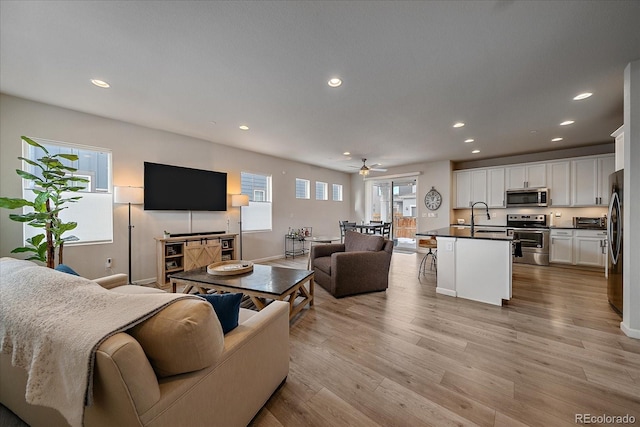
<box><xmin>22</xmin><ymin>138</ymin><xmax>113</xmax><ymax>246</ymax></box>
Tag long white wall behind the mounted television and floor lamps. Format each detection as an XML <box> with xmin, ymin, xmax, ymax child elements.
<box><xmin>0</xmin><ymin>94</ymin><xmax>351</xmax><ymax>280</ymax></box>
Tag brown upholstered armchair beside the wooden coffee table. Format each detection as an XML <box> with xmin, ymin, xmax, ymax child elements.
<box><xmin>310</xmin><ymin>231</ymin><xmax>393</xmax><ymax>298</ymax></box>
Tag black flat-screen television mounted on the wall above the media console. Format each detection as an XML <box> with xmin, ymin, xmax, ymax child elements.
<box><xmin>144</xmin><ymin>162</ymin><xmax>227</xmax><ymax>211</ymax></box>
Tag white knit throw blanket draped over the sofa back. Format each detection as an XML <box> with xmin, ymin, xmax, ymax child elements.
<box><xmin>0</xmin><ymin>258</ymin><xmax>198</xmax><ymax>427</ymax></box>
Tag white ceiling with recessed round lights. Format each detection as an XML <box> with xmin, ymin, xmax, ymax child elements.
<box><xmin>0</xmin><ymin>0</ymin><xmax>640</xmax><ymax>172</ymax></box>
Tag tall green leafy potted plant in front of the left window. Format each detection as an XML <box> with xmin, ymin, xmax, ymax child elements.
<box><xmin>0</xmin><ymin>136</ymin><xmax>89</xmax><ymax>268</ymax></box>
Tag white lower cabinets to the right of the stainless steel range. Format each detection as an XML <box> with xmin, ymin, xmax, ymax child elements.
<box><xmin>549</xmin><ymin>229</ymin><xmax>607</xmax><ymax>267</ymax></box>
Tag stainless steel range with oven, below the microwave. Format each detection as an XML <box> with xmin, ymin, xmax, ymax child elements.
<box><xmin>507</xmin><ymin>215</ymin><xmax>549</xmax><ymax>265</ymax></box>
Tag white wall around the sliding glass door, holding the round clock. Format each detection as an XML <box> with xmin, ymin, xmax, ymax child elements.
<box><xmin>349</xmin><ymin>161</ymin><xmax>452</xmax><ymax>231</ymax></box>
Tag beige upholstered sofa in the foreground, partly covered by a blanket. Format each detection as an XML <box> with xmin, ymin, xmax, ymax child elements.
<box><xmin>0</xmin><ymin>275</ymin><xmax>289</xmax><ymax>427</ymax></box>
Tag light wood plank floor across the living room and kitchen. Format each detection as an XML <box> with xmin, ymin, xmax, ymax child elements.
<box><xmin>251</xmin><ymin>253</ymin><xmax>640</xmax><ymax>427</ymax></box>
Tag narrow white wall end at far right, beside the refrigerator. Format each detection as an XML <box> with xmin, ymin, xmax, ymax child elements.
<box><xmin>621</xmin><ymin>61</ymin><xmax>640</xmax><ymax>339</ymax></box>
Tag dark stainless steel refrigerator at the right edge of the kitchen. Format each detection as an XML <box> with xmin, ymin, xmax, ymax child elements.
<box><xmin>607</xmin><ymin>170</ymin><xmax>624</xmax><ymax>316</ymax></box>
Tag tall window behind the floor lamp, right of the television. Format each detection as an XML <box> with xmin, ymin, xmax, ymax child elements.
<box><xmin>240</xmin><ymin>172</ymin><xmax>272</xmax><ymax>231</ymax></box>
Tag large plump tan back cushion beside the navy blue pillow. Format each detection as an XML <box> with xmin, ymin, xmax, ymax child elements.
<box><xmin>127</xmin><ymin>298</ymin><xmax>224</xmax><ymax>377</ymax></box>
